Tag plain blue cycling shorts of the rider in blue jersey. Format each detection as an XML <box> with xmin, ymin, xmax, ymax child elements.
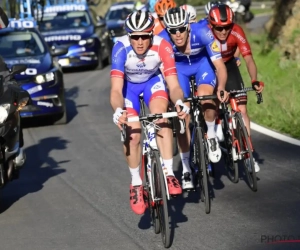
<box><xmin>176</xmin><ymin>57</ymin><xmax>216</xmax><ymax>98</ymax></box>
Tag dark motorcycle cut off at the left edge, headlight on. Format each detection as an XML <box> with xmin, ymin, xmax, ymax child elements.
<box><xmin>0</xmin><ymin>64</ymin><xmax>31</xmax><ymax>188</ymax></box>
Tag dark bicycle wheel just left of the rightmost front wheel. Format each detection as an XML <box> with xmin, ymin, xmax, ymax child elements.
<box><xmin>222</xmin><ymin>113</ymin><xmax>239</xmax><ymax>183</ymax></box>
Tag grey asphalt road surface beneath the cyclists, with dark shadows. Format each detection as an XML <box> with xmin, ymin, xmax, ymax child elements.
<box><xmin>0</xmin><ymin>14</ymin><xmax>300</xmax><ymax>250</ymax></box>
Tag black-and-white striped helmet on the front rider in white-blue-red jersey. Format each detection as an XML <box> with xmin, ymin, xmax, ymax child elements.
<box><xmin>125</xmin><ymin>10</ymin><xmax>154</xmax><ymax>33</ymax></box>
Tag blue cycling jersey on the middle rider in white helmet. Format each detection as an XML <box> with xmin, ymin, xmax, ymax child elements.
<box><xmin>159</xmin><ymin>21</ymin><xmax>222</xmax><ymax>65</ymax></box>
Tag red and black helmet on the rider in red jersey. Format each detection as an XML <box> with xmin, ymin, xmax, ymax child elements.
<box><xmin>208</xmin><ymin>4</ymin><xmax>234</xmax><ymax>26</ymax></box>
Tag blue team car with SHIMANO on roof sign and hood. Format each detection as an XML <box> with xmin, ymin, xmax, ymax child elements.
<box><xmin>34</xmin><ymin>0</ymin><xmax>113</xmax><ymax>69</ymax></box>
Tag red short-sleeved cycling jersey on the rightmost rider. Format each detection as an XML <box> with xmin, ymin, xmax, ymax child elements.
<box><xmin>215</xmin><ymin>24</ymin><xmax>252</xmax><ymax>62</ymax></box>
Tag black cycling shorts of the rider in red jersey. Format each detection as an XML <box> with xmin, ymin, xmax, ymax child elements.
<box><xmin>225</xmin><ymin>58</ymin><xmax>247</xmax><ymax>105</ymax></box>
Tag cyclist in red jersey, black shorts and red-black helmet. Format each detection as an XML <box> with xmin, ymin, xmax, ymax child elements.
<box><xmin>208</xmin><ymin>4</ymin><xmax>264</xmax><ymax>172</ymax></box>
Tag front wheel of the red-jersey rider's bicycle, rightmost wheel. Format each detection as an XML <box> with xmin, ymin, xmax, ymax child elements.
<box><xmin>235</xmin><ymin>113</ymin><xmax>257</xmax><ymax>192</ymax></box>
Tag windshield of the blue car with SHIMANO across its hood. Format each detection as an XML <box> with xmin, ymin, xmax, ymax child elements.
<box><xmin>40</xmin><ymin>11</ymin><xmax>91</xmax><ymax>31</ymax></box>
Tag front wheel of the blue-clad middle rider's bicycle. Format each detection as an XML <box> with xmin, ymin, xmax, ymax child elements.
<box><xmin>195</xmin><ymin>127</ymin><xmax>210</xmax><ymax>214</ymax></box>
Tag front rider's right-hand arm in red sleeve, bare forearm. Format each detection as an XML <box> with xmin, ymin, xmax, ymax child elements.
<box><xmin>158</xmin><ymin>39</ymin><xmax>183</xmax><ymax>103</ymax></box>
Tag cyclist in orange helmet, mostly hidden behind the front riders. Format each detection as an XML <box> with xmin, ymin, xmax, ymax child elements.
<box><xmin>153</xmin><ymin>0</ymin><xmax>176</xmax><ymax>35</ymax></box>
